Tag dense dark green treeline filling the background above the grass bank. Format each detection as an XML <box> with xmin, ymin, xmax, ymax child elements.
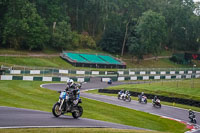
<box><xmin>0</xmin><ymin>0</ymin><xmax>200</xmax><ymax>59</ymax></box>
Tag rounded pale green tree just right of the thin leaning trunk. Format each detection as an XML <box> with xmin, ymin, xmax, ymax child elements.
<box><xmin>136</xmin><ymin>10</ymin><xmax>166</xmax><ymax>57</ymax></box>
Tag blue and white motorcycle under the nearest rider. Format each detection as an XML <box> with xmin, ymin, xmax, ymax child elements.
<box><xmin>52</xmin><ymin>91</ymin><xmax>83</xmax><ymax>119</ymax></box>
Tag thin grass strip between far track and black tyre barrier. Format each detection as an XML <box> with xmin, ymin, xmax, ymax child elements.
<box><xmin>87</xmin><ymin>90</ymin><xmax>200</xmax><ymax>112</ymax></box>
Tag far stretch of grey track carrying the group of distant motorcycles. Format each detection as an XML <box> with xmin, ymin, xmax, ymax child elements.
<box><xmin>42</xmin><ymin>80</ymin><xmax>200</xmax><ymax>131</ymax></box>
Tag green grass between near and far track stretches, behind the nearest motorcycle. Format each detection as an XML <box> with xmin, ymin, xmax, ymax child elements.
<box><xmin>0</xmin><ymin>81</ymin><xmax>186</xmax><ymax>133</ymax></box>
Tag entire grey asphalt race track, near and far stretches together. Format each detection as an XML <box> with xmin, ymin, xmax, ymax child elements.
<box><xmin>0</xmin><ymin>78</ymin><xmax>200</xmax><ymax>133</ymax></box>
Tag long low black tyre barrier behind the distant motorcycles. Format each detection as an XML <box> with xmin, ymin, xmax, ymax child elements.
<box><xmin>98</xmin><ymin>89</ymin><xmax>200</xmax><ymax>107</ymax></box>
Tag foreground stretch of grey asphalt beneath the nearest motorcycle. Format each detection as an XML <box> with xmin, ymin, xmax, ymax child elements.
<box><xmin>0</xmin><ymin>106</ymin><xmax>145</xmax><ymax>130</ymax></box>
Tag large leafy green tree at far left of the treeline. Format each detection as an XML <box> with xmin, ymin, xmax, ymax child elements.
<box><xmin>3</xmin><ymin>0</ymin><xmax>49</xmax><ymax>50</ymax></box>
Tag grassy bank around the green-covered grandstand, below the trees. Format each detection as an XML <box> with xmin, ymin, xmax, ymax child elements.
<box><xmin>0</xmin><ymin>49</ymin><xmax>200</xmax><ymax>68</ymax></box>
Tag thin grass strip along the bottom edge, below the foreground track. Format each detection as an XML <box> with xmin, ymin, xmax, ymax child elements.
<box><xmin>0</xmin><ymin>128</ymin><xmax>161</xmax><ymax>133</ymax></box>
